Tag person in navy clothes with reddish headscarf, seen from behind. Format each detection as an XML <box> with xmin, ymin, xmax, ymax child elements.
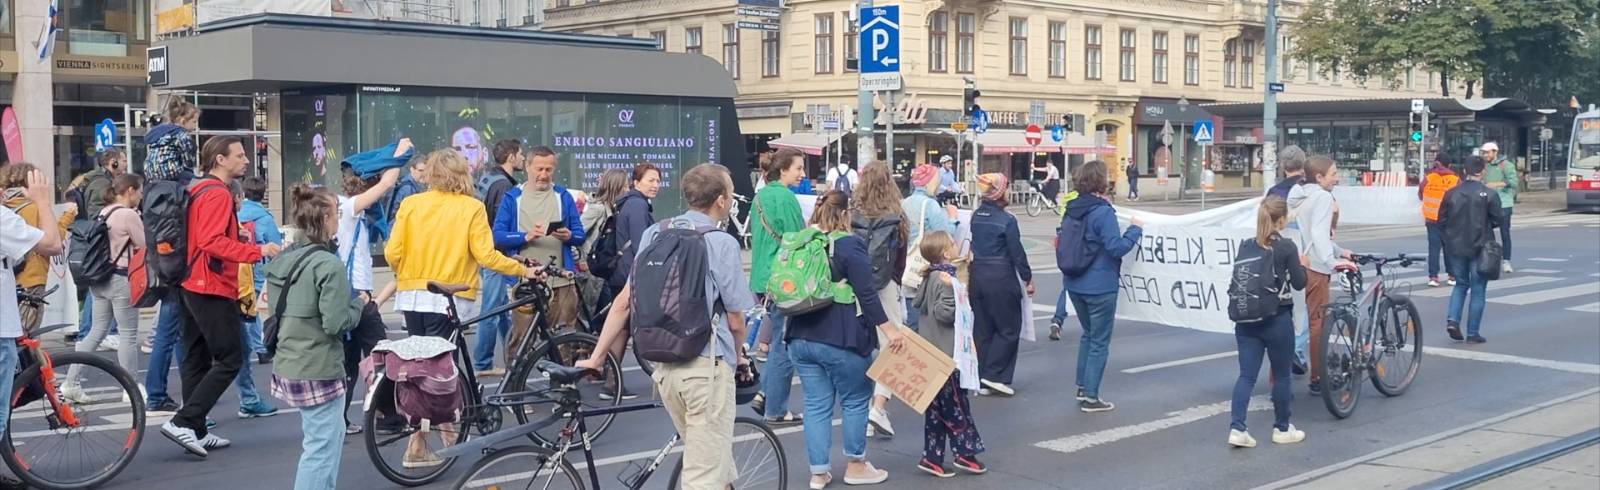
<box><xmin>971</xmin><ymin>173</ymin><xmax>1034</xmax><ymax>397</ymax></box>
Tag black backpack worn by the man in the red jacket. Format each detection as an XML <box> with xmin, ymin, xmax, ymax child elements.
<box><xmin>134</xmin><ymin>178</ymin><xmax>227</xmax><ymax>307</ymax></box>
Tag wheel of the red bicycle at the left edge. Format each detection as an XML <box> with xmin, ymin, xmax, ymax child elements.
<box><xmin>0</xmin><ymin>351</ymin><xmax>144</xmax><ymax>488</ymax></box>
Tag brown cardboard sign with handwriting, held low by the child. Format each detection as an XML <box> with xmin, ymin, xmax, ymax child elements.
<box><xmin>867</xmin><ymin>328</ymin><xmax>955</xmax><ymax>413</ymax></box>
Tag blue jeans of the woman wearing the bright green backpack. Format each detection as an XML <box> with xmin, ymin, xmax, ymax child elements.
<box><xmin>790</xmin><ymin>339</ymin><xmax>872</xmax><ymax>474</ymax></box>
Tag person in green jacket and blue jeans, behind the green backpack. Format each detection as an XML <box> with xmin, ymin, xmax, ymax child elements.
<box><xmin>750</xmin><ymin>147</ymin><xmax>805</xmax><ymax>428</ymax></box>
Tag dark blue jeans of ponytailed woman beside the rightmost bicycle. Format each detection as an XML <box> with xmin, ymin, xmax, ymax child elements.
<box><xmin>1230</xmin><ymin>309</ymin><xmax>1294</xmax><ymax>431</ymax></box>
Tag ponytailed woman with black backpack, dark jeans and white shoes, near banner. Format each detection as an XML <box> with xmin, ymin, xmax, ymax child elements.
<box><xmin>1227</xmin><ymin>195</ymin><xmax>1306</xmax><ymax>447</ymax></box>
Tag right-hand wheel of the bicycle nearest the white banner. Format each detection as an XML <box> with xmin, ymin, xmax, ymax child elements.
<box><xmin>1373</xmin><ymin>298</ymin><xmax>1422</xmax><ymax>397</ymax></box>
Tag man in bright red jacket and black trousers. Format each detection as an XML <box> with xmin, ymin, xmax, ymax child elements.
<box><xmin>162</xmin><ymin>136</ymin><xmax>280</xmax><ymax>458</ymax></box>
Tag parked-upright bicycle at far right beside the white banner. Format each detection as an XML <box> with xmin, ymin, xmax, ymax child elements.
<box><xmin>1317</xmin><ymin>253</ymin><xmax>1422</xmax><ymax>418</ymax></box>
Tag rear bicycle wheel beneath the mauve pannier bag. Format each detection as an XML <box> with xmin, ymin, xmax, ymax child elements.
<box><xmin>362</xmin><ymin>376</ymin><xmax>478</xmax><ymax>487</ymax></box>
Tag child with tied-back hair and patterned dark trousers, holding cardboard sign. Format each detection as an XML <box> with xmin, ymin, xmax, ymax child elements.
<box><xmin>912</xmin><ymin>231</ymin><xmax>989</xmax><ymax>479</ymax></box>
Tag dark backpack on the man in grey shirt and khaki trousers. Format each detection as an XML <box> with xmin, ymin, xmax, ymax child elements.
<box><xmin>629</xmin><ymin>219</ymin><xmax>720</xmax><ymax>362</ymax></box>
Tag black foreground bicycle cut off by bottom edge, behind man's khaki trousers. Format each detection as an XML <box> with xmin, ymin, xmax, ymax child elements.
<box><xmin>442</xmin><ymin>362</ymin><xmax>789</xmax><ymax>490</ymax></box>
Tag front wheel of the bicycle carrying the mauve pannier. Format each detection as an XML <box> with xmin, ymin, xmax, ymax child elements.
<box><xmin>501</xmin><ymin>331</ymin><xmax>622</xmax><ymax>447</ymax></box>
